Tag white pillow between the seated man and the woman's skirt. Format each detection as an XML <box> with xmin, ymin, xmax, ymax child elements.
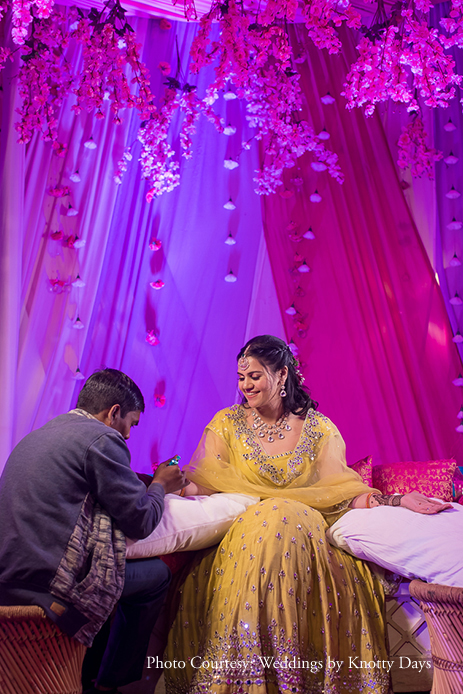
<box><xmin>127</xmin><ymin>494</ymin><xmax>259</xmax><ymax>559</ymax></box>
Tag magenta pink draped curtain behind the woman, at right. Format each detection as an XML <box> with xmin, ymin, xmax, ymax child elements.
<box><xmin>264</xmin><ymin>25</ymin><xmax>462</xmax><ymax>463</ymax></box>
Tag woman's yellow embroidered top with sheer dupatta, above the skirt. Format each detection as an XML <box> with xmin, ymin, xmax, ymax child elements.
<box><xmin>185</xmin><ymin>405</ymin><xmax>371</xmax><ymax>515</ymax></box>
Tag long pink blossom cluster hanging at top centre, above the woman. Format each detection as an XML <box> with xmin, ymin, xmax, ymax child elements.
<box><xmin>191</xmin><ymin>0</ymin><xmax>343</xmax><ymax>194</ymax></box>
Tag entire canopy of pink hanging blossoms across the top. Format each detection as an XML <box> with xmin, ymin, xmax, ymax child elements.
<box><xmin>0</xmin><ymin>0</ymin><xmax>463</xmax><ymax>193</ymax></box>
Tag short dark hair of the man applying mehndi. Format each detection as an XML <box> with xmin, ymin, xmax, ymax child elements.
<box><xmin>77</xmin><ymin>369</ymin><xmax>145</xmax><ymax>418</ymax></box>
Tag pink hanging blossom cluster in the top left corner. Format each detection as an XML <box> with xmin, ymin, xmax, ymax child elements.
<box><xmin>5</xmin><ymin>0</ymin><xmax>156</xmax><ymax>144</ymax></box>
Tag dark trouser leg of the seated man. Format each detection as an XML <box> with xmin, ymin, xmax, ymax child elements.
<box><xmin>82</xmin><ymin>558</ymin><xmax>171</xmax><ymax>691</ymax></box>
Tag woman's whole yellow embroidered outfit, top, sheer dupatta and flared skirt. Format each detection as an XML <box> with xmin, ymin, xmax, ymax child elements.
<box><xmin>164</xmin><ymin>405</ymin><xmax>389</xmax><ymax>694</ymax></box>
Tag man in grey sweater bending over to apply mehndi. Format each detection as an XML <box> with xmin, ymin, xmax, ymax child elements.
<box><xmin>0</xmin><ymin>369</ymin><xmax>186</xmax><ymax>692</ymax></box>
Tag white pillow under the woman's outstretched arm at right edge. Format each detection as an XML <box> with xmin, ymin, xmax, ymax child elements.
<box><xmin>326</xmin><ymin>504</ymin><xmax>463</xmax><ymax>587</ymax></box>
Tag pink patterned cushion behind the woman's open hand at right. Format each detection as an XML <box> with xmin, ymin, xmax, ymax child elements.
<box><xmin>373</xmin><ymin>460</ymin><xmax>456</xmax><ymax>501</ymax></box>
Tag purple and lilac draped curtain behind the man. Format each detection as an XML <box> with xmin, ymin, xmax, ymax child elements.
<box><xmin>0</xmin><ymin>13</ymin><xmax>268</xmax><ymax>471</ymax></box>
